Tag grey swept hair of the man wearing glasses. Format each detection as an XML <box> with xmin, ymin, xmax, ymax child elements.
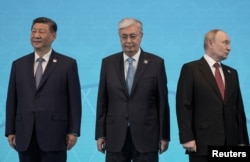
<box><xmin>118</xmin><ymin>18</ymin><xmax>143</xmax><ymax>33</ymax></box>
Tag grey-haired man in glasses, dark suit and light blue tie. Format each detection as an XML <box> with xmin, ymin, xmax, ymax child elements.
<box><xmin>95</xmin><ymin>18</ymin><xmax>170</xmax><ymax>162</ymax></box>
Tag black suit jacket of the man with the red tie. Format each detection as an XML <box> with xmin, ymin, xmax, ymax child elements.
<box><xmin>176</xmin><ymin>58</ymin><xmax>249</xmax><ymax>155</ymax></box>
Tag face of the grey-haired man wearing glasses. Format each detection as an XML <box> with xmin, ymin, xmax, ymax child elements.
<box><xmin>119</xmin><ymin>25</ymin><xmax>142</xmax><ymax>56</ymax></box>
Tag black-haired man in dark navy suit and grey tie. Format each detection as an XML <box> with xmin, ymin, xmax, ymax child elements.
<box><xmin>5</xmin><ymin>17</ymin><xmax>81</xmax><ymax>162</ymax></box>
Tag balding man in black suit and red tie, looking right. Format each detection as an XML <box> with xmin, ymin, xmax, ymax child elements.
<box><xmin>176</xmin><ymin>30</ymin><xmax>249</xmax><ymax>162</ymax></box>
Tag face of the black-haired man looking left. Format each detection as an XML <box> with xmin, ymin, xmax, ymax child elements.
<box><xmin>30</xmin><ymin>23</ymin><xmax>56</xmax><ymax>51</ymax></box>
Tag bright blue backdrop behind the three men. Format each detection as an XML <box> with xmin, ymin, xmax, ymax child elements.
<box><xmin>0</xmin><ymin>0</ymin><xmax>250</xmax><ymax>162</ymax></box>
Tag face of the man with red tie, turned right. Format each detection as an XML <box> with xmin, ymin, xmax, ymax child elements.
<box><xmin>211</xmin><ymin>31</ymin><xmax>231</xmax><ymax>61</ymax></box>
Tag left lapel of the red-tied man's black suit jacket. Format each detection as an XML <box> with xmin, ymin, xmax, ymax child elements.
<box><xmin>199</xmin><ymin>58</ymin><xmax>222</xmax><ymax>99</ymax></box>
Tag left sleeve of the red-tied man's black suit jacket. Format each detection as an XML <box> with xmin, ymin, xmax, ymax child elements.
<box><xmin>176</xmin><ymin>65</ymin><xmax>194</xmax><ymax>143</ymax></box>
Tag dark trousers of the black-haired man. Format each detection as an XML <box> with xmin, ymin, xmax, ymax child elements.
<box><xmin>18</xmin><ymin>131</ymin><xmax>67</xmax><ymax>162</ymax></box>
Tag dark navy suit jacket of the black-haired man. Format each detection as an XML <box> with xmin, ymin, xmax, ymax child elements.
<box><xmin>5</xmin><ymin>51</ymin><xmax>81</xmax><ymax>151</ymax></box>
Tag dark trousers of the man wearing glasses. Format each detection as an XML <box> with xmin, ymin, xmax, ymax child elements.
<box><xmin>106</xmin><ymin>128</ymin><xmax>159</xmax><ymax>162</ymax></box>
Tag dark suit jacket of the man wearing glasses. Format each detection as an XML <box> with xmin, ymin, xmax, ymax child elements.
<box><xmin>95</xmin><ymin>51</ymin><xmax>170</xmax><ymax>152</ymax></box>
